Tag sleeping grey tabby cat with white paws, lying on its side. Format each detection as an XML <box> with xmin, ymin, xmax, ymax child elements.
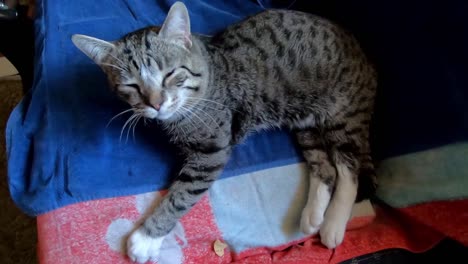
<box><xmin>72</xmin><ymin>2</ymin><xmax>377</xmax><ymax>262</ymax></box>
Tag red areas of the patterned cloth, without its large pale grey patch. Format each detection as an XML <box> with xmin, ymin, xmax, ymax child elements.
<box><xmin>38</xmin><ymin>191</ymin><xmax>468</xmax><ymax>264</ymax></box>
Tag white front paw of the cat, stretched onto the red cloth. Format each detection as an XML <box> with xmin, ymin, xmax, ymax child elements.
<box><xmin>127</xmin><ymin>227</ymin><xmax>164</xmax><ymax>263</ymax></box>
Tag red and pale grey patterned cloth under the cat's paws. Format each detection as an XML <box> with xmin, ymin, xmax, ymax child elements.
<box><xmin>37</xmin><ymin>164</ymin><xmax>468</xmax><ymax>264</ymax></box>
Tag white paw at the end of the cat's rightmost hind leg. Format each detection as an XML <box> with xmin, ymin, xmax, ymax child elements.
<box><xmin>320</xmin><ymin>218</ymin><xmax>346</xmax><ymax>249</ymax></box>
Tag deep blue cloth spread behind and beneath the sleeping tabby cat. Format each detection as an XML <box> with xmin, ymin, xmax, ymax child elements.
<box><xmin>6</xmin><ymin>0</ymin><xmax>468</xmax><ymax>215</ymax></box>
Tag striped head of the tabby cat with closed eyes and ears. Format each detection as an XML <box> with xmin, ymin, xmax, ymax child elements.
<box><xmin>72</xmin><ymin>2</ymin><xmax>208</xmax><ymax>121</ymax></box>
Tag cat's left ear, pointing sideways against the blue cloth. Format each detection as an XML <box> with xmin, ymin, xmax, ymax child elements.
<box><xmin>72</xmin><ymin>34</ymin><xmax>115</xmax><ymax>64</ymax></box>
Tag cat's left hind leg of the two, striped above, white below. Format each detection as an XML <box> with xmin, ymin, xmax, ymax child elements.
<box><xmin>296</xmin><ymin>128</ymin><xmax>336</xmax><ymax>234</ymax></box>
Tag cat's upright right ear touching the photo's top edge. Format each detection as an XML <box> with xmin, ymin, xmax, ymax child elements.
<box><xmin>159</xmin><ymin>2</ymin><xmax>192</xmax><ymax>49</ymax></box>
